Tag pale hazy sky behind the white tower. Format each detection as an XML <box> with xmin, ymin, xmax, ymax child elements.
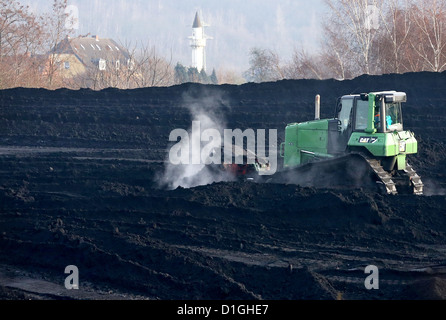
<box><xmin>21</xmin><ymin>0</ymin><xmax>325</xmax><ymax>71</ymax></box>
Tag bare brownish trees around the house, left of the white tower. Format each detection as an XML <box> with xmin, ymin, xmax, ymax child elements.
<box><xmin>0</xmin><ymin>0</ymin><xmax>183</xmax><ymax>90</ymax></box>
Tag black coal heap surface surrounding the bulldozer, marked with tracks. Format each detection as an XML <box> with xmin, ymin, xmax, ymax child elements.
<box><xmin>0</xmin><ymin>73</ymin><xmax>446</xmax><ymax>300</ymax></box>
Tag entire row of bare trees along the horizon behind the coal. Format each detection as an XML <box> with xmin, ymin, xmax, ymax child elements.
<box><xmin>0</xmin><ymin>0</ymin><xmax>446</xmax><ymax>90</ymax></box>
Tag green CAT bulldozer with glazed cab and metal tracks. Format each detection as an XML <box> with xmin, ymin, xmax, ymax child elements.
<box><xmin>280</xmin><ymin>91</ymin><xmax>423</xmax><ymax>195</ymax></box>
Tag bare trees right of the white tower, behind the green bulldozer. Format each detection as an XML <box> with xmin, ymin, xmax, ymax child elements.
<box><xmin>244</xmin><ymin>0</ymin><xmax>446</xmax><ymax>82</ymax></box>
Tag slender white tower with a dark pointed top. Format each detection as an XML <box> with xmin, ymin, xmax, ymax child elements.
<box><xmin>189</xmin><ymin>12</ymin><xmax>212</xmax><ymax>72</ymax></box>
